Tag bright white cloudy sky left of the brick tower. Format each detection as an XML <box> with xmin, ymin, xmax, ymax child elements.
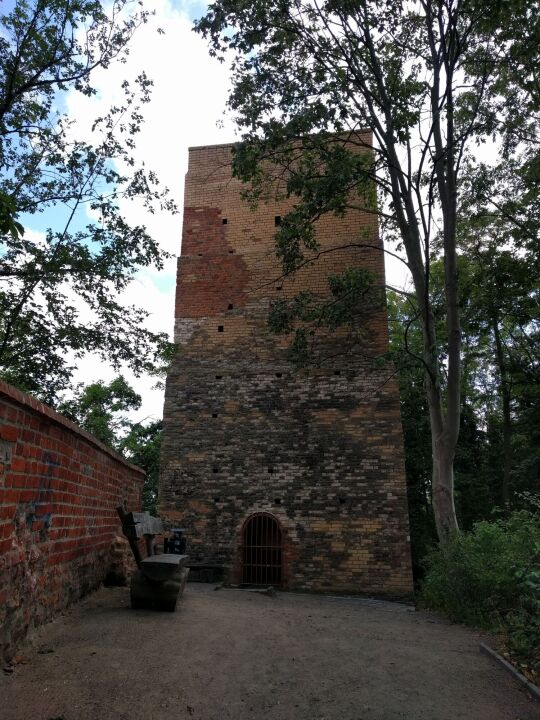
<box><xmin>21</xmin><ymin>0</ymin><xmax>410</xmax><ymax>421</ymax></box>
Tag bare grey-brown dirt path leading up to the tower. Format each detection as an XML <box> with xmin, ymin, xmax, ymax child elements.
<box><xmin>0</xmin><ymin>584</ymin><xmax>540</xmax><ymax>720</ymax></box>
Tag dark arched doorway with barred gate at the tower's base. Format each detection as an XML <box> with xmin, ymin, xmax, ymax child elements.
<box><xmin>240</xmin><ymin>513</ymin><xmax>282</xmax><ymax>587</ymax></box>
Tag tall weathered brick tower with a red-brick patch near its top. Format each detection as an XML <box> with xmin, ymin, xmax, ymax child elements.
<box><xmin>159</xmin><ymin>136</ymin><xmax>412</xmax><ymax>596</ymax></box>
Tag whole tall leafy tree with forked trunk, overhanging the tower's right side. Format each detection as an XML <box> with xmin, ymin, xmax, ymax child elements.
<box><xmin>197</xmin><ymin>0</ymin><xmax>540</xmax><ymax>541</ymax></box>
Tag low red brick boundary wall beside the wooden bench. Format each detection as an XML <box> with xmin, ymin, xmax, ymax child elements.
<box><xmin>0</xmin><ymin>381</ymin><xmax>144</xmax><ymax>660</ymax></box>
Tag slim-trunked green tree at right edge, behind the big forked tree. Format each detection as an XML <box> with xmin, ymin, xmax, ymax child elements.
<box><xmin>458</xmin><ymin>155</ymin><xmax>540</xmax><ymax>506</ymax></box>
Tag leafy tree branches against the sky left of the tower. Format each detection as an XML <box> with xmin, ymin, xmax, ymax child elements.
<box><xmin>0</xmin><ymin>0</ymin><xmax>174</xmax><ymax>402</ymax></box>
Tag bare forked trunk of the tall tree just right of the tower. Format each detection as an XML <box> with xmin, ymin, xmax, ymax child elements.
<box><xmin>372</xmin><ymin>3</ymin><xmax>461</xmax><ymax>545</ymax></box>
